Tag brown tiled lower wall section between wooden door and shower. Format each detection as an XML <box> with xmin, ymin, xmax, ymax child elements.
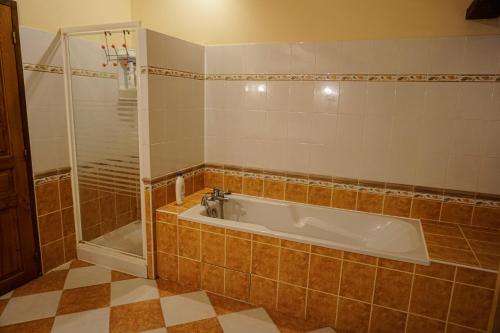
<box><xmin>35</xmin><ymin>178</ymin><xmax>76</xmax><ymax>273</ymax></box>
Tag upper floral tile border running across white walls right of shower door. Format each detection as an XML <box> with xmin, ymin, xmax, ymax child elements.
<box><xmin>141</xmin><ymin>66</ymin><xmax>500</xmax><ymax>82</ymax></box>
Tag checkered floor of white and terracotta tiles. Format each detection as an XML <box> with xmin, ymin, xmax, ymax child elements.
<box><xmin>0</xmin><ymin>260</ymin><xmax>333</xmax><ymax>333</ymax></box>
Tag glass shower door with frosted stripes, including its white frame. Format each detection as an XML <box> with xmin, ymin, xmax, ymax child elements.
<box><xmin>62</xmin><ymin>23</ymin><xmax>146</xmax><ymax>276</ymax></box>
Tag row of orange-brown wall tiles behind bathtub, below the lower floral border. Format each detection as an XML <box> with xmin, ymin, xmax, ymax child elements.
<box><xmin>204</xmin><ymin>168</ymin><xmax>500</xmax><ymax>230</ymax></box>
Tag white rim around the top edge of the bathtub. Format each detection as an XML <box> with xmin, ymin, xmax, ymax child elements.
<box><xmin>177</xmin><ymin>194</ymin><xmax>431</xmax><ymax>266</ymax></box>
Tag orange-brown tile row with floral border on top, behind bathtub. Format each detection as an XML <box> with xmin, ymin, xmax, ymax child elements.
<box><xmin>204</xmin><ymin>164</ymin><xmax>500</xmax><ymax>218</ymax></box>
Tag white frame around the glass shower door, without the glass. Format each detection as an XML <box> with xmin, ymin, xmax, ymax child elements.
<box><xmin>60</xmin><ymin>22</ymin><xmax>148</xmax><ymax>277</ymax></box>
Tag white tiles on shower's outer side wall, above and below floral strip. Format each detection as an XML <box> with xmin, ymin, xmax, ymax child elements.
<box><xmin>146</xmin><ymin>30</ymin><xmax>204</xmax><ymax>178</ymax></box>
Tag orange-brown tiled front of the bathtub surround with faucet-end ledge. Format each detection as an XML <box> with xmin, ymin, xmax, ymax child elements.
<box><xmin>156</xmin><ymin>192</ymin><xmax>497</xmax><ymax>332</ymax></box>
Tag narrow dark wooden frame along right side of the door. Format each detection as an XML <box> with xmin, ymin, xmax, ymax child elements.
<box><xmin>0</xmin><ymin>0</ymin><xmax>42</xmax><ymax>274</ymax></box>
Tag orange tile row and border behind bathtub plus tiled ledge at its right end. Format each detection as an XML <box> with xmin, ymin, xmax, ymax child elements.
<box><xmin>205</xmin><ymin>165</ymin><xmax>500</xmax><ymax>270</ymax></box>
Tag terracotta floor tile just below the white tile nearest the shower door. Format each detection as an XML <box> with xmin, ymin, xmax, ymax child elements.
<box><xmin>57</xmin><ymin>283</ymin><xmax>111</xmax><ymax>315</ymax></box>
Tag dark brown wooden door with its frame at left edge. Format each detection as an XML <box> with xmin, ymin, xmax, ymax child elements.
<box><xmin>0</xmin><ymin>0</ymin><xmax>40</xmax><ymax>295</ymax></box>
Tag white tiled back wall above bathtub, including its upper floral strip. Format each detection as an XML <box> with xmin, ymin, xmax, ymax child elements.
<box><xmin>205</xmin><ymin>36</ymin><xmax>500</xmax><ymax>194</ymax></box>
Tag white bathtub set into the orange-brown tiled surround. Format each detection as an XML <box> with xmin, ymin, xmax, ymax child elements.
<box><xmin>179</xmin><ymin>194</ymin><xmax>429</xmax><ymax>265</ymax></box>
